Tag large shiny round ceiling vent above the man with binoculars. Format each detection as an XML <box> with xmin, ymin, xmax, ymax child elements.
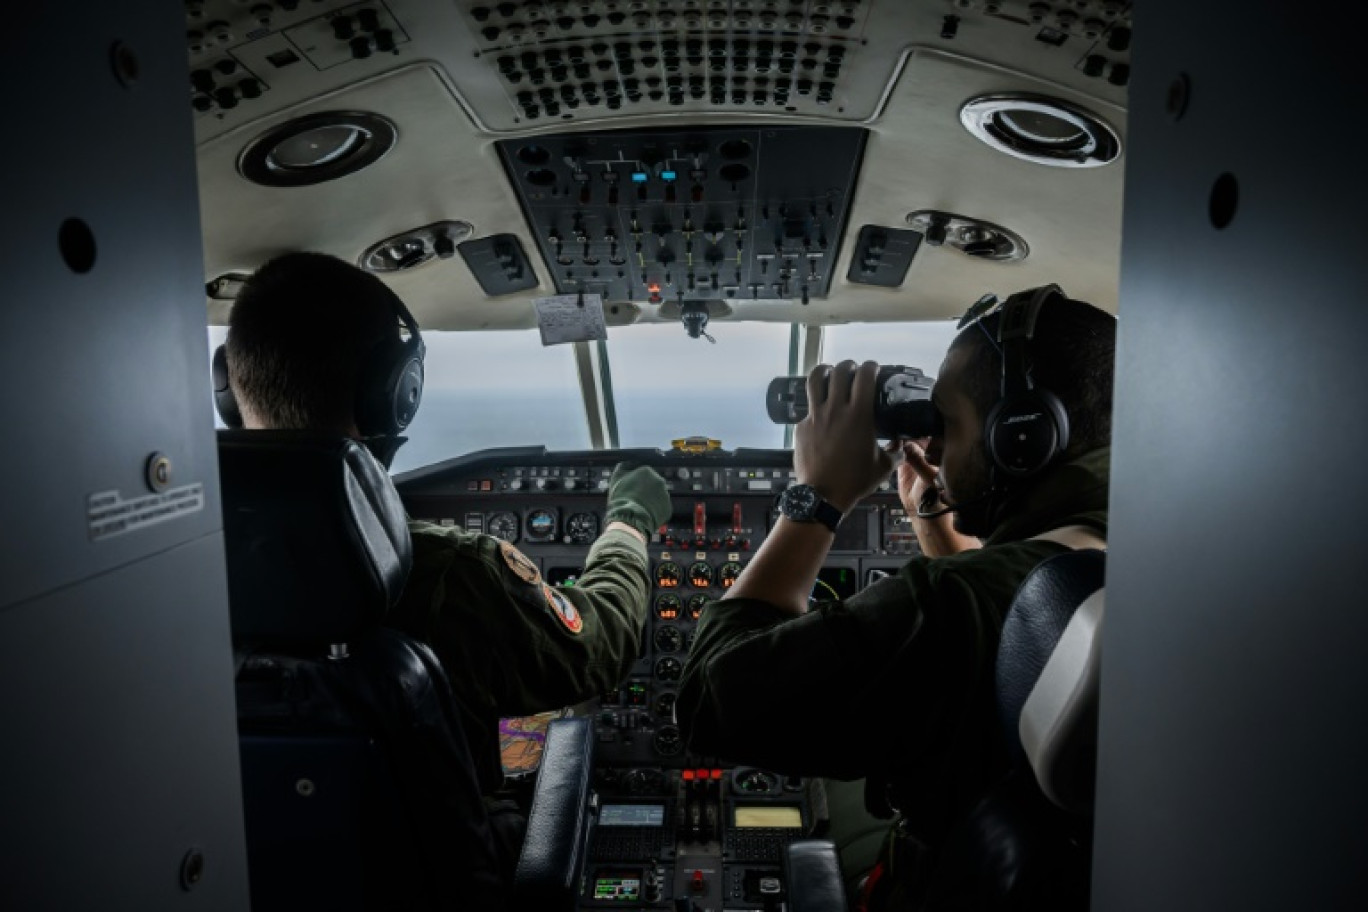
<box><xmin>959</xmin><ymin>94</ymin><xmax>1120</xmax><ymax>168</ymax></box>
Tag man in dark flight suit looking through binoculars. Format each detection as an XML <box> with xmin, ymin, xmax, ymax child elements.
<box><xmin>676</xmin><ymin>286</ymin><xmax>1116</xmax><ymax>909</ymax></box>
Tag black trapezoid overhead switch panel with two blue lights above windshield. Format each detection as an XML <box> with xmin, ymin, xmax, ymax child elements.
<box><xmin>497</xmin><ymin>126</ymin><xmax>866</xmax><ymax>305</ymax></box>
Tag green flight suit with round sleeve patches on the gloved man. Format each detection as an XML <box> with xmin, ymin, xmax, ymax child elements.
<box><xmin>386</xmin><ymin>521</ymin><xmax>650</xmax><ymax>794</ymax></box>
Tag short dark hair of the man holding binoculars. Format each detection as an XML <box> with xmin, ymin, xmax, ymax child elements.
<box><xmin>949</xmin><ymin>295</ymin><xmax>1116</xmax><ymax>458</ymax></box>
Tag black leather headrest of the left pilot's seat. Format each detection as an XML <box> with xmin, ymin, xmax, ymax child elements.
<box><xmin>219</xmin><ymin>431</ymin><xmax>413</xmax><ymax>643</ymax></box>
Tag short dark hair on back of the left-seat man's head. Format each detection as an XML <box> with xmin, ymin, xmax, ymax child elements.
<box><xmin>224</xmin><ymin>253</ymin><xmax>399</xmax><ymax>431</ymax></box>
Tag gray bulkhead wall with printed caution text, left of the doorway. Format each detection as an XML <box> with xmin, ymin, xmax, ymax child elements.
<box><xmin>0</xmin><ymin>0</ymin><xmax>248</xmax><ymax>912</ymax></box>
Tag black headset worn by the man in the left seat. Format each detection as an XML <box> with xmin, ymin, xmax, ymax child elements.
<box><xmin>213</xmin><ymin>295</ymin><xmax>427</xmax><ymax>438</ymax></box>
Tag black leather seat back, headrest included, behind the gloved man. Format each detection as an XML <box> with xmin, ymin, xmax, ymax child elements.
<box><xmin>220</xmin><ymin>431</ymin><xmax>506</xmax><ymax>912</ymax></box>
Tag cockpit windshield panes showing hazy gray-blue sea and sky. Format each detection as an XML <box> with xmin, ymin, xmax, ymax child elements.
<box><xmin>208</xmin><ymin>321</ymin><xmax>955</xmax><ymax>473</ymax></box>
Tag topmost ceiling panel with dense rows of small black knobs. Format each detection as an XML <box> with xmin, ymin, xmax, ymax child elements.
<box><xmin>465</xmin><ymin>0</ymin><xmax>886</xmax><ymax>123</ymax></box>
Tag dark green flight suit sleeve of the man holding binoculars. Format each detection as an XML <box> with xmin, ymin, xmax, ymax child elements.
<box><xmin>676</xmin><ymin>561</ymin><xmax>995</xmax><ymax>779</ymax></box>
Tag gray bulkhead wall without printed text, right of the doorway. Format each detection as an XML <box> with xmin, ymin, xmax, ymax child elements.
<box><xmin>1093</xmin><ymin>0</ymin><xmax>1368</xmax><ymax>912</ymax></box>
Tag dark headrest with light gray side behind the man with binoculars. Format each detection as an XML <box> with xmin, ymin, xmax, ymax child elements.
<box><xmin>997</xmin><ymin>551</ymin><xmax>1107</xmax><ymax>814</ymax></box>
